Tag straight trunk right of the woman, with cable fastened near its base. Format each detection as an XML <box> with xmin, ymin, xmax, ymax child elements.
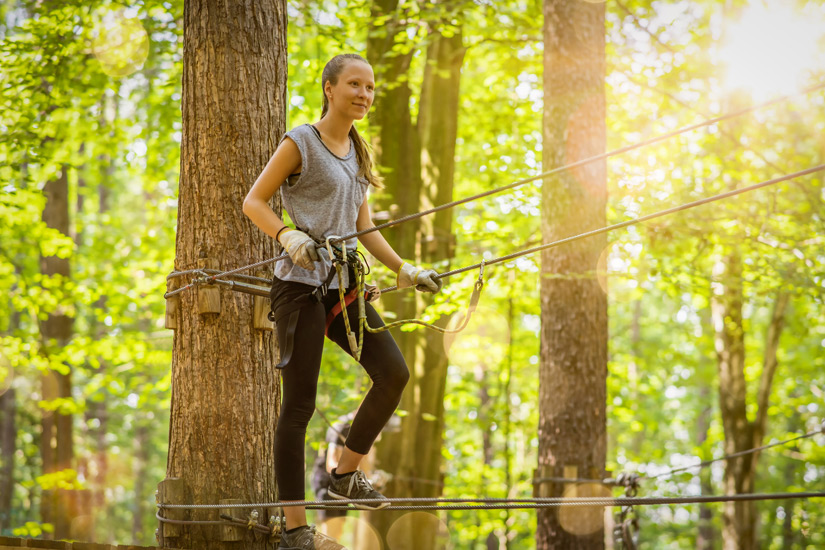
<box><xmin>536</xmin><ymin>0</ymin><xmax>607</xmax><ymax>550</ymax></box>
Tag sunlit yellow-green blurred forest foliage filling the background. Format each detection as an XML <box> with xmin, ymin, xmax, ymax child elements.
<box><xmin>0</xmin><ymin>0</ymin><xmax>825</xmax><ymax>549</ymax></box>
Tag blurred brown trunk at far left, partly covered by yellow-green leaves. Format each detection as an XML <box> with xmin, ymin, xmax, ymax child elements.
<box><xmin>40</xmin><ymin>167</ymin><xmax>74</xmax><ymax>539</ymax></box>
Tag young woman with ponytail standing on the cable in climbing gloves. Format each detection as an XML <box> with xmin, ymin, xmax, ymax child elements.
<box><xmin>243</xmin><ymin>54</ymin><xmax>441</xmax><ymax>550</ymax></box>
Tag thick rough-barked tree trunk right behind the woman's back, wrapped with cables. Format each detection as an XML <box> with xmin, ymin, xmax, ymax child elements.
<box><xmin>161</xmin><ymin>0</ymin><xmax>286</xmax><ymax>549</ymax></box>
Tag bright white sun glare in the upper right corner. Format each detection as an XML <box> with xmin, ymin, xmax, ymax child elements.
<box><xmin>719</xmin><ymin>0</ymin><xmax>825</xmax><ymax>99</ymax></box>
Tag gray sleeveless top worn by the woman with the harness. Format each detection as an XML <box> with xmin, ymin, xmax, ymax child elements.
<box><xmin>275</xmin><ymin>124</ymin><xmax>369</xmax><ymax>288</ymax></box>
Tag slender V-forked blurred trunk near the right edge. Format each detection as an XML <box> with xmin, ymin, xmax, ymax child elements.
<box><xmin>711</xmin><ymin>245</ymin><xmax>789</xmax><ymax>550</ymax></box>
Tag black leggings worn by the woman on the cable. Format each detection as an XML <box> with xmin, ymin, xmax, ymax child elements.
<box><xmin>272</xmin><ymin>279</ymin><xmax>410</xmax><ymax>500</ymax></box>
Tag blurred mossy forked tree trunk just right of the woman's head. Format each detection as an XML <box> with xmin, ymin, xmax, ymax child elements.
<box><xmin>367</xmin><ymin>0</ymin><xmax>464</xmax><ymax>550</ymax></box>
